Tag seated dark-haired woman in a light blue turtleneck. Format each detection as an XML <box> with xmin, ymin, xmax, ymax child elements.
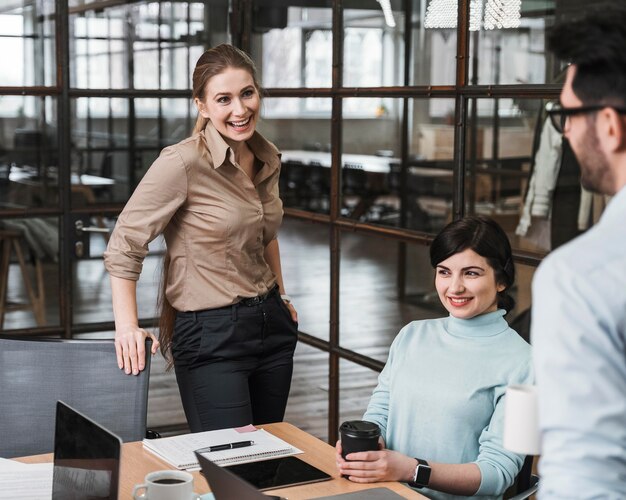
<box><xmin>337</xmin><ymin>217</ymin><xmax>533</xmax><ymax>498</ymax></box>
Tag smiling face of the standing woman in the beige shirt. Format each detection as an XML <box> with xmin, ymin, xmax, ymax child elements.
<box><xmin>196</xmin><ymin>68</ymin><xmax>261</xmax><ymax>145</ymax></box>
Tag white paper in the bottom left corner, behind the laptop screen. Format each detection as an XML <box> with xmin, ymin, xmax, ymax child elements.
<box><xmin>0</xmin><ymin>460</ymin><xmax>52</xmax><ymax>500</ymax></box>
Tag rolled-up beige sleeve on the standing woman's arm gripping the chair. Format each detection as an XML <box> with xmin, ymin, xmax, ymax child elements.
<box><xmin>104</xmin><ymin>147</ymin><xmax>187</xmax><ymax>281</ymax></box>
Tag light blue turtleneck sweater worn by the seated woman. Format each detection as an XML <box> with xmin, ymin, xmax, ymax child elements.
<box><xmin>363</xmin><ymin>310</ymin><xmax>533</xmax><ymax>498</ymax></box>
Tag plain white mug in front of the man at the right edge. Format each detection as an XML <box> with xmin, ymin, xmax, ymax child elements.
<box><xmin>502</xmin><ymin>385</ymin><xmax>541</xmax><ymax>455</ymax></box>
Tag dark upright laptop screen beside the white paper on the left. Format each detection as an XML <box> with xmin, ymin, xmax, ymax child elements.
<box><xmin>52</xmin><ymin>401</ymin><xmax>122</xmax><ymax>500</ymax></box>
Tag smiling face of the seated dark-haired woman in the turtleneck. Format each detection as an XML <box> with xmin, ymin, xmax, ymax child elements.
<box><xmin>435</xmin><ymin>248</ymin><xmax>505</xmax><ymax>319</ymax></box>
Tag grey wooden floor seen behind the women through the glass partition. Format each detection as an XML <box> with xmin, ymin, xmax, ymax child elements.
<box><xmin>4</xmin><ymin>220</ymin><xmax>528</xmax><ymax>440</ymax></box>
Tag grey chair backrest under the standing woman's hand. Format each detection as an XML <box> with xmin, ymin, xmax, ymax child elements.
<box><xmin>0</xmin><ymin>336</ymin><xmax>150</xmax><ymax>458</ymax></box>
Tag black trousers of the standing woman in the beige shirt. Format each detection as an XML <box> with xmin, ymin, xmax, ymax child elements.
<box><xmin>172</xmin><ymin>288</ymin><xmax>298</xmax><ymax>432</ymax></box>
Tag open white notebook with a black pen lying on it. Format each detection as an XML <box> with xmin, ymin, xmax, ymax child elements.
<box><xmin>143</xmin><ymin>429</ymin><xmax>302</xmax><ymax>469</ymax></box>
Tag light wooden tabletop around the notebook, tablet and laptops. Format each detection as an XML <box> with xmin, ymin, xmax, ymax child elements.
<box><xmin>16</xmin><ymin>422</ymin><xmax>425</xmax><ymax>500</ymax></box>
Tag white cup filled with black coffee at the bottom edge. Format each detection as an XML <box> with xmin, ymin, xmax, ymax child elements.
<box><xmin>133</xmin><ymin>470</ymin><xmax>200</xmax><ymax>500</ymax></box>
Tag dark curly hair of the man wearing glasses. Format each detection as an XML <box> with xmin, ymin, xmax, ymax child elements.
<box><xmin>548</xmin><ymin>7</ymin><xmax>626</xmax><ymax>106</ymax></box>
